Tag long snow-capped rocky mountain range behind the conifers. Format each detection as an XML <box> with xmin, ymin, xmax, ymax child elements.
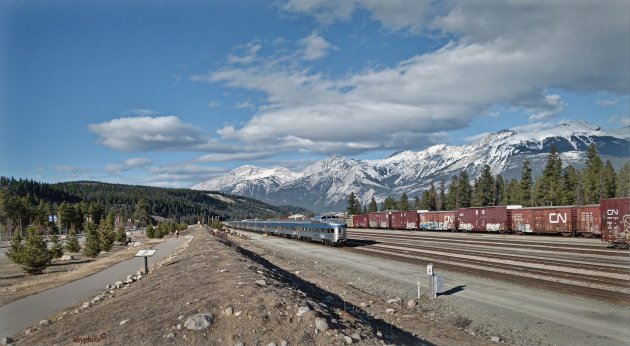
<box><xmin>193</xmin><ymin>121</ymin><xmax>630</xmax><ymax>211</ymax></box>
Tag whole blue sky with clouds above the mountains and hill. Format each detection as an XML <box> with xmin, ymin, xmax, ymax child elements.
<box><xmin>0</xmin><ymin>0</ymin><xmax>630</xmax><ymax>187</ymax></box>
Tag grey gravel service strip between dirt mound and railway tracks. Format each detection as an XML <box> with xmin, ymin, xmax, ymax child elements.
<box><xmin>242</xmin><ymin>230</ymin><xmax>630</xmax><ymax>345</ymax></box>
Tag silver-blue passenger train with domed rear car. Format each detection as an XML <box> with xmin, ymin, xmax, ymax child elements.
<box><xmin>225</xmin><ymin>215</ymin><xmax>347</xmax><ymax>246</ymax></box>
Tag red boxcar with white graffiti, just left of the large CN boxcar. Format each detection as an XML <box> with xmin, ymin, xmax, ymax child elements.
<box><xmin>456</xmin><ymin>206</ymin><xmax>512</xmax><ymax>232</ymax></box>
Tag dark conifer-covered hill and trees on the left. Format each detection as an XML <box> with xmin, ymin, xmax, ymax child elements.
<box><xmin>0</xmin><ymin>177</ymin><xmax>305</xmax><ymax>237</ymax></box>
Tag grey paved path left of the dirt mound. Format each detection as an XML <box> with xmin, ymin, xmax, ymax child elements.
<box><xmin>0</xmin><ymin>238</ymin><xmax>183</xmax><ymax>337</ymax></box>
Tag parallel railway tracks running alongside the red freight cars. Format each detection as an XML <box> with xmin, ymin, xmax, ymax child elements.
<box><xmin>344</xmin><ymin>231</ymin><xmax>630</xmax><ymax>305</ymax></box>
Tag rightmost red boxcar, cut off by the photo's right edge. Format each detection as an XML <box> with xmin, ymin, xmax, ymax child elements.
<box><xmin>599</xmin><ymin>197</ymin><xmax>630</xmax><ymax>246</ymax></box>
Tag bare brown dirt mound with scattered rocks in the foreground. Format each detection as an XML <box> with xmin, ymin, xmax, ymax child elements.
<box><xmin>15</xmin><ymin>228</ymin><xmax>489</xmax><ymax>345</ymax></box>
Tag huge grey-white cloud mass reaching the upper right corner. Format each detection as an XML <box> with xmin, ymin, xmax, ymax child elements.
<box><xmin>191</xmin><ymin>0</ymin><xmax>630</xmax><ymax>157</ymax></box>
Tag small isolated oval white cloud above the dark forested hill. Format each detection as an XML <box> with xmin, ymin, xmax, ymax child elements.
<box><xmin>88</xmin><ymin>115</ymin><xmax>209</xmax><ymax>151</ymax></box>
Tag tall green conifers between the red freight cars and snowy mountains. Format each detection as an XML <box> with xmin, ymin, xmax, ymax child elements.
<box><xmin>347</xmin><ymin>144</ymin><xmax>630</xmax><ymax>214</ymax></box>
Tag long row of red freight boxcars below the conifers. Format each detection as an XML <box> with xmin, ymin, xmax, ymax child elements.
<box><xmin>352</xmin><ymin>197</ymin><xmax>630</xmax><ymax>247</ymax></box>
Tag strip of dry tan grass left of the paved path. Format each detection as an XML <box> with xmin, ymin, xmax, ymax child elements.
<box><xmin>0</xmin><ymin>240</ymin><xmax>162</xmax><ymax>306</ymax></box>
